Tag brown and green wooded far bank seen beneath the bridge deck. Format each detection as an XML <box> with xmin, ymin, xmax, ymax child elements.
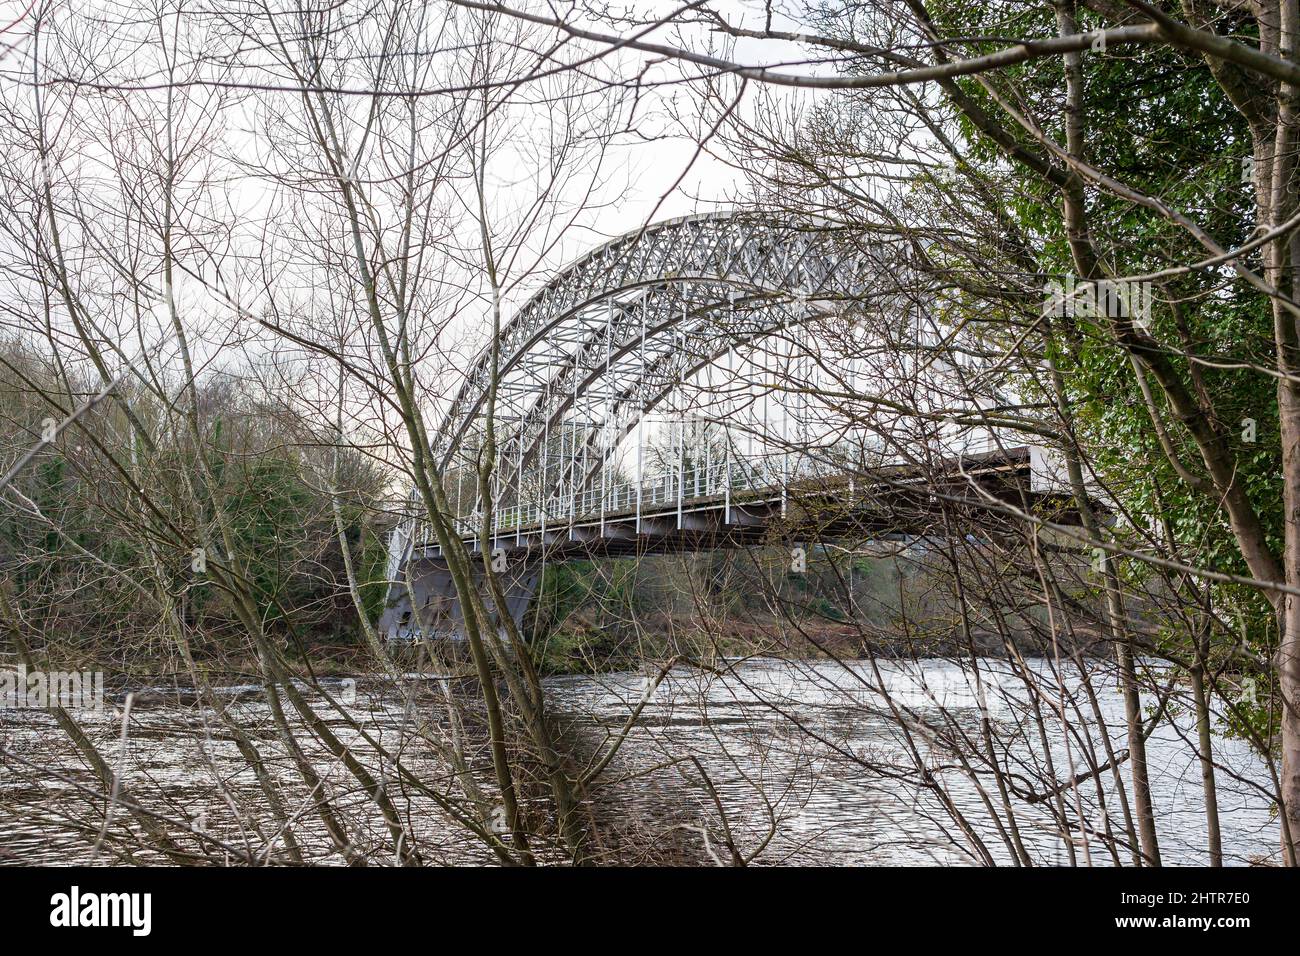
<box><xmin>528</xmin><ymin>542</ymin><xmax>1086</xmax><ymax>674</ymax></box>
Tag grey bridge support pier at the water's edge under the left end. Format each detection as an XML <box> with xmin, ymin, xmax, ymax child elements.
<box><xmin>380</xmin><ymin>555</ymin><xmax>541</xmax><ymax>644</ymax></box>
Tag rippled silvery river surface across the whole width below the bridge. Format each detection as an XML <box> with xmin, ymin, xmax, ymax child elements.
<box><xmin>0</xmin><ymin>661</ymin><xmax>1275</xmax><ymax>865</ymax></box>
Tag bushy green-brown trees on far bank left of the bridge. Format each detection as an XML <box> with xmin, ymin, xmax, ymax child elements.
<box><xmin>0</xmin><ymin>342</ymin><xmax>387</xmax><ymax>665</ymax></box>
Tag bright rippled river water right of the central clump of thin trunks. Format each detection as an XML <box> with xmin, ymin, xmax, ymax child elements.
<box><xmin>543</xmin><ymin>661</ymin><xmax>1277</xmax><ymax>865</ymax></box>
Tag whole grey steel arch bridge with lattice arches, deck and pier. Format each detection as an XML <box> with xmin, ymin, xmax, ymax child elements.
<box><xmin>380</xmin><ymin>213</ymin><xmax>1053</xmax><ymax>640</ymax></box>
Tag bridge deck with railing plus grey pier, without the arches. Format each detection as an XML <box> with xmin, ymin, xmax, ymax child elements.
<box><xmin>380</xmin><ymin>449</ymin><xmax>1076</xmax><ymax>641</ymax></box>
